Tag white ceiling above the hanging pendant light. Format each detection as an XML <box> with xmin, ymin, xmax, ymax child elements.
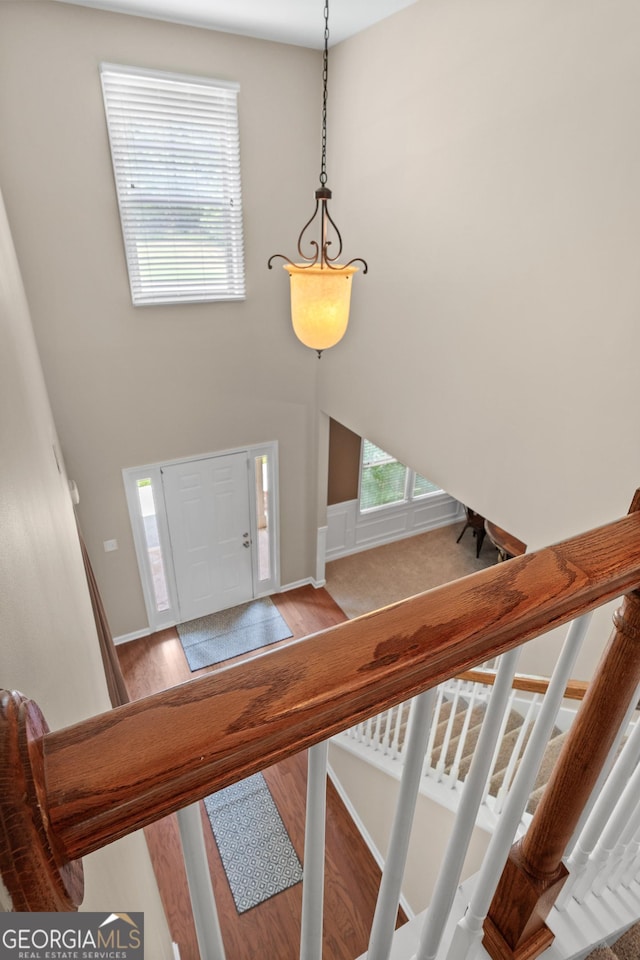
<box><xmin>50</xmin><ymin>0</ymin><xmax>416</xmax><ymax>49</ymax></box>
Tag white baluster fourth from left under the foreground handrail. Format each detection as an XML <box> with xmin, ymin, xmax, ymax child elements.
<box><xmin>416</xmin><ymin>649</ymin><xmax>520</xmax><ymax>960</ymax></box>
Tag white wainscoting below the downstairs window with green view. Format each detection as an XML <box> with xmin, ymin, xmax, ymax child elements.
<box><xmin>326</xmin><ymin>492</ymin><xmax>464</xmax><ymax>560</ymax></box>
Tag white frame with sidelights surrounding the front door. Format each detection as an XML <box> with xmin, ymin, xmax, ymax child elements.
<box><xmin>122</xmin><ymin>440</ymin><xmax>280</xmax><ymax>632</ymax></box>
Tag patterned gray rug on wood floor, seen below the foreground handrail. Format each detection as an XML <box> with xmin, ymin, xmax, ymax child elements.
<box><xmin>204</xmin><ymin>773</ymin><xmax>302</xmax><ymax>913</ymax></box>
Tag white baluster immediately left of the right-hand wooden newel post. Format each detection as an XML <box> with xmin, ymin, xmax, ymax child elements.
<box><xmin>447</xmin><ymin>614</ymin><xmax>591</xmax><ymax>960</ymax></box>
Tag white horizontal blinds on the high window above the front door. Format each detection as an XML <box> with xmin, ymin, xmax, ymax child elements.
<box><xmin>100</xmin><ymin>64</ymin><xmax>245</xmax><ymax>304</ymax></box>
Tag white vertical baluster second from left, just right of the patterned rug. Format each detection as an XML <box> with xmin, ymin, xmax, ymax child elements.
<box><xmin>300</xmin><ymin>740</ymin><xmax>329</xmax><ymax>960</ymax></box>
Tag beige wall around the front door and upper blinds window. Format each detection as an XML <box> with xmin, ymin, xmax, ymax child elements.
<box><xmin>0</xmin><ymin>0</ymin><xmax>321</xmax><ymax>636</ymax></box>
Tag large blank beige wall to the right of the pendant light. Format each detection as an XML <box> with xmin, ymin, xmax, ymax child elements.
<box><xmin>320</xmin><ymin>0</ymin><xmax>640</xmax><ymax>548</ymax></box>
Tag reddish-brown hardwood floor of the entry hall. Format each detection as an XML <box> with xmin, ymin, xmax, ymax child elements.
<box><xmin>118</xmin><ymin>587</ymin><xmax>405</xmax><ymax>960</ymax></box>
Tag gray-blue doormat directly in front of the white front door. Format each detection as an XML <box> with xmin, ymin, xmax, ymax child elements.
<box><xmin>177</xmin><ymin>597</ymin><xmax>293</xmax><ymax>671</ymax></box>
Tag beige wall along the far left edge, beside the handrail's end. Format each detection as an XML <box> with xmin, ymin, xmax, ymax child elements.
<box><xmin>0</xmin><ymin>186</ymin><xmax>173</xmax><ymax>944</ymax></box>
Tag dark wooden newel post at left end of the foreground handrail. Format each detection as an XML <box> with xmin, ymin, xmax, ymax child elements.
<box><xmin>0</xmin><ymin>691</ymin><xmax>84</xmax><ymax>912</ymax></box>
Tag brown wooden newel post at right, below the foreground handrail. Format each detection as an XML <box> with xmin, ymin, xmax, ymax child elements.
<box><xmin>483</xmin><ymin>494</ymin><xmax>640</xmax><ymax>960</ymax></box>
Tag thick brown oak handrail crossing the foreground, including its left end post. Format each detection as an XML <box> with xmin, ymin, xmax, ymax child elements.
<box><xmin>0</xmin><ymin>506</ymin><xmax>640</xmax><ymax>910</ymax></box>
